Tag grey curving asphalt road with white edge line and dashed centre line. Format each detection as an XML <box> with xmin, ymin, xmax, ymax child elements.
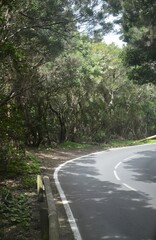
<box><xmin>55</xmin><ymin>144</ymin><xmax>156</xmax><ymax>240</ymax></box>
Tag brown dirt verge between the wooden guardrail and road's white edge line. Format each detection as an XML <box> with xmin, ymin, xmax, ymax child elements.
<box><xmin>33</xmin><ymin>146</ymin><xmax>101</xmax><ymax>240</ymax></box>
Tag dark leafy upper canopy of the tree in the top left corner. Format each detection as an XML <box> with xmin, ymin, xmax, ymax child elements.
<box><xmin>0</xmin><ymin>0</ymin><xmax>73</xmax><ymax>105</ymax></box>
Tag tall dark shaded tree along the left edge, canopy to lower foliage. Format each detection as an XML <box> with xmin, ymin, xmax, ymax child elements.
<box><xmin>0</xmin><ymin>0</ymin><xmax>75</xmax><ymax>169</ymax></box>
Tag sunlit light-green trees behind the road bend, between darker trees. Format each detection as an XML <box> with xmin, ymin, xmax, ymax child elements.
<box><xmin>40</xmin><ymin>36</ymin><xmax>154</xmax><ymax>142</ymax></box>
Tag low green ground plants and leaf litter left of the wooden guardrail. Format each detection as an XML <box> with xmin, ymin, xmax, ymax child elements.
<box><xmin>0</xmin><ymin>154</ymin><xmax>40</xmax><ymax>240</ymax></box>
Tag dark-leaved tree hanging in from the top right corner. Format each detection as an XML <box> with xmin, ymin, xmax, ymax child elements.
<box><xmin>106</xmin><ymin>0</ymin><xmax>156</xmax><ymax>84</ymax></box>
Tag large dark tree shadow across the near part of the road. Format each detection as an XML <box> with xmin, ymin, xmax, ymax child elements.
<box><xmin>60</xmin><ymin>152</ymin><xmax>156</xmax><ymax>240</ymax></box>
